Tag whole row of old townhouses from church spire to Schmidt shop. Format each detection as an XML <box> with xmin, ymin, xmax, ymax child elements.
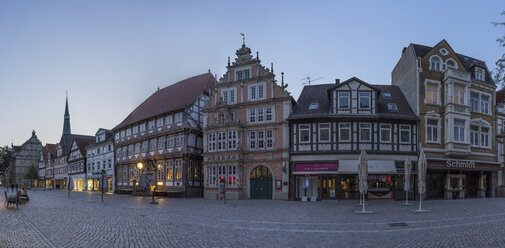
<box><xmin>18</xmin><ymin>40</ymin><xmax>505</xmax><ymax>201</ymax></box>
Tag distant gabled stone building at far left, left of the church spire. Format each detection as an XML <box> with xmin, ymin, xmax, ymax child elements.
<box><xmin>6</xmin><ymin>131</ymin><xmax>43</xmax><ymax>187</ymax></box>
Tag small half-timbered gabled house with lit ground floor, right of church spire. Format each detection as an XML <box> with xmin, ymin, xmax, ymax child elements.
<box><xmin>67</xmin><ymin>135</ymin><xmax>95</xmax><ymax>191</ymax></box>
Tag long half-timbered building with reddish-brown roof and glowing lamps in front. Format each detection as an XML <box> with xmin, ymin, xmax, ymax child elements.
<box><xmin>113</xmin><ymin>73</ymin><xmax>216</xmax><ymax>197</ymax></box>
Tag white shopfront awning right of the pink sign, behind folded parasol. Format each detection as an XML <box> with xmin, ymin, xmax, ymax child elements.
<box><xmin>338</xmin><ymin>160</ymin><xmax>396</xmax><ymax>174</ymax></box>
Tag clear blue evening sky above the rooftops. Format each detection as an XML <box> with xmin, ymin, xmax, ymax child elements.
<box><xmin>0</xmin><ymin>0</ymin><xmax>505</xmax><ymax>145</ymax></box>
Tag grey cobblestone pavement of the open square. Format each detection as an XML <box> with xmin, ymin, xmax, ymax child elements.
<box><xmin>0</xmin><ymin>188</ymin><xmax>505</xmax><ymax>247</ymax></box>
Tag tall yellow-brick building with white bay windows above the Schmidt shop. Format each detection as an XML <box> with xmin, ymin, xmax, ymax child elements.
<box><xmin>392</xmin><ymin>40</ymin><xmax>500</xmax><ymax>199</ymax></box>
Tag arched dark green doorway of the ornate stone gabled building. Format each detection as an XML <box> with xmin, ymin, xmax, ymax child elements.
<box><xmin>250</xmin><ymin>166</ymin><xmax>272</xmax><ymax>199</ymax></box>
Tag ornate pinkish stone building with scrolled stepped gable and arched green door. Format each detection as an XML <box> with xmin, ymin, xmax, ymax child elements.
<box><xmin>204</xmin><ymin>41</ymin><xmax>294</xmax><ymax>199</ymax></box>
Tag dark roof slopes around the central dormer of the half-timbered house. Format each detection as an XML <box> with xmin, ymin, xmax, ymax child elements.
<box><xmin>289</xmin><ymin>84</ymin><xmax>418</xmax><ymax>120</ymax></box>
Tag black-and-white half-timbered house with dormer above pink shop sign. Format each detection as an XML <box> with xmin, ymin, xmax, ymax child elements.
<box><xmin>289</xmin><ymin>77</ymin><xmax>418</xmax><ymax>201</ymax></box>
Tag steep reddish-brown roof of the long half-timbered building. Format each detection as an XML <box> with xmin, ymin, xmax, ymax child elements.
<box><xmin>112</xmin><ymin>73</ymin><xmax>216</xmax><ymax>130</ymax></box>
